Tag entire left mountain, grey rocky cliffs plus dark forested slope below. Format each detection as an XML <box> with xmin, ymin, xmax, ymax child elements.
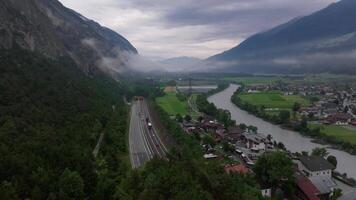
<box><xmin>0</xmin><ymin>0</ymin><xmax>137</xmax><ymax>199</ymax></box>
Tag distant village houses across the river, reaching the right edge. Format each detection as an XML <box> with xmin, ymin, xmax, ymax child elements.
<box><xmin>245</xmin><ymin>83</ymin><xmax>356</xmax><ymax>126</ymax></box>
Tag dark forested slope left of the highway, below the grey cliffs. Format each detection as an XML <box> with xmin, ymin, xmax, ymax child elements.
<box><xmin>0</xmin><ymin>50</ymin><xmax>128</xmax><ymax>199</ymax></box>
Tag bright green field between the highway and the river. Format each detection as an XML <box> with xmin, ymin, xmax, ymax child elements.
<box><xmin>156</xmin><ymin>92</ymin><xmax>188</xmax><ymax>116</ymax></box>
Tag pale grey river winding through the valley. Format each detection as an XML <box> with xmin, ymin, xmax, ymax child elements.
<box><xmin>208</xmin><ymin>84</ymin><xmax>356</xmax><ymax>178</ymax></box>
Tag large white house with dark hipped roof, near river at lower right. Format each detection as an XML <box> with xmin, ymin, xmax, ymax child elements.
<box><xmin>298</xmin><ymin>156</ymin><xmax>335</xmax><ymax>177</ymax></box>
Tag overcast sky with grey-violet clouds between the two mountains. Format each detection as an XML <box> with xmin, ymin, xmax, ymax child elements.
<box><xmin>60</xmin><ymin>0</ymin><xmax>337</xmax><ymax>59</ymax></box>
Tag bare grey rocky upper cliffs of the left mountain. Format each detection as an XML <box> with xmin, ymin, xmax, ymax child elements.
<box><xmin>0</xmin><ymin>0</ymin><xmax>137</xmax><ymax>74</ymax></box>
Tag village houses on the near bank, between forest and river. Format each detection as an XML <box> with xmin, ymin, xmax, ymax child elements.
<box><xmin>179</xmin><ymin>96</ymin><xmax>354</xmax><ymax>200</ymax></box>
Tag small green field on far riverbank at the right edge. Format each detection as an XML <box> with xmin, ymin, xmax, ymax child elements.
<box><xmin>309</xmin><ymin>124</ymin><xmax>356</xmax><ymax>144</ymax></box>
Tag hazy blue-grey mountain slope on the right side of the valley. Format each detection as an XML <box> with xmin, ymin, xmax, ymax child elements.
<box><xmin>208</xmin><ymin>0</ymin><xmax>356</xmax><ymax>73</ymax></box>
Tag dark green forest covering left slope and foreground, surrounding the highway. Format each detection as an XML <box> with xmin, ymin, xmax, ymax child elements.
<box><xmin>0</xmin><ymin>50</ymin><xmax>268</xmax><ymax>200</ymax></box>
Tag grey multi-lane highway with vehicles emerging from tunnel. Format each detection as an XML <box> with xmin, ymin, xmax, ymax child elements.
<box><xmin>129</xmin><ymin>100</ymin><xmax>167</xmax><ymax>169</ymax></box>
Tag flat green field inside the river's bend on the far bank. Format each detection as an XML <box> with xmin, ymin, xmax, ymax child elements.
<box><xmin>239</xmin><ymin>92</ymin><xmax>309</xmax><ymax>109</ymax></box>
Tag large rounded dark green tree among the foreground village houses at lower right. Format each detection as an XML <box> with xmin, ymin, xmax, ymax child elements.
<box><xmin>254</xmin><ymin>151</ymin><xmax>295</xmax><ymax>193</ymax></box>
